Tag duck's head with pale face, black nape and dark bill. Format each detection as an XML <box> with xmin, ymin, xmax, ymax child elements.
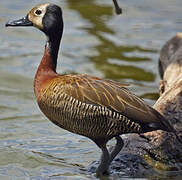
<box><xmin>6</xmin><ymin>3</ymin><xmax>63</xmax><ymax>36</ymax></box>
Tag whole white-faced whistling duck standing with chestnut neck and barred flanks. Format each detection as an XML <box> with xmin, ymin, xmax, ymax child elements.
<box><xmin>6</xmin><ymin>4</ymin><xmax>181</xmax><ymax>176</ymax></box>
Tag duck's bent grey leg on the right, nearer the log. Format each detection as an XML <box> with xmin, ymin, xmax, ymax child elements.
<box><xmin>110</xmin><ymin>136</ymin><xmax>124</xmax><ymax>163</ymax></box>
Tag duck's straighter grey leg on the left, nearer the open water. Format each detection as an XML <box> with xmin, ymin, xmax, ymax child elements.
<box><xmin>96</xmin><ymin>146</ymin><xmax>110</xmax><ymax>177</ymax></box>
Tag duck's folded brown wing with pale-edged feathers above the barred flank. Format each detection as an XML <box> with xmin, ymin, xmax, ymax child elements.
<box><xmin>56</xmin><ymin>75</ymin><xmax>159</xmax><ymax>124</ymax></box>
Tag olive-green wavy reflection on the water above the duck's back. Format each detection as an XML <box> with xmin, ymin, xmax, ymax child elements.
<box><xmin>68</xmin><ymin>0</ymin><xmax>155</xmax><ymax>82</ymax></box>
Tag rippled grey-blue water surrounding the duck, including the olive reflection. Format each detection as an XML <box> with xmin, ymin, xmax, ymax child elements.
<box><xmin>0</xmin><ymin>0</ymin><xmax>182</xmax><ymax>180</ymax></box>
